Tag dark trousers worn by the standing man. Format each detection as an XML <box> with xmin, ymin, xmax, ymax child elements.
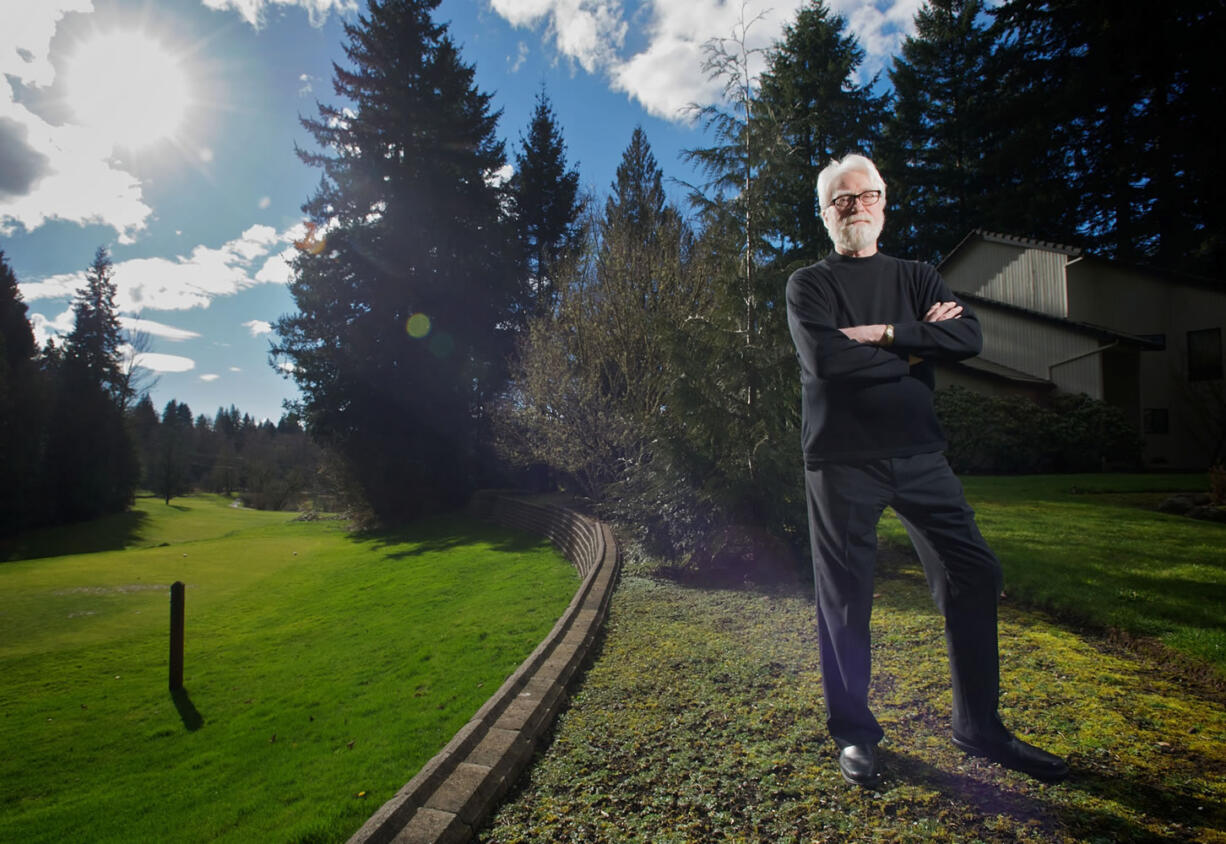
<box><xmin>804</xmin><ymin>453</ymin><xmax>1009</xmax><ymax>747</ymax></box>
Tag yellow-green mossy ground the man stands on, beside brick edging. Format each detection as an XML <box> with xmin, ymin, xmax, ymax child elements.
<box><xmin>479</xmin><ymin>551</ymin><xmax>1226</xmax><ymax>844</ymax></box>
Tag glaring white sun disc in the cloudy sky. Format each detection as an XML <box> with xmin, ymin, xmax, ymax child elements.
<box><xmin>65</xmin><ymin>31</ymin><xmax>190</xmax><ymax>148</ymax></box>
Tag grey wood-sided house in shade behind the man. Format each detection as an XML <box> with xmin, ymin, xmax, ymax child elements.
<box><xmin>937</xmin><ymin>229</ymin><xmax>1226</xmax><ymax>470</ymax></box>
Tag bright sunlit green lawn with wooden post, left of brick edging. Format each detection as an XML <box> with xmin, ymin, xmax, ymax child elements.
<box><xmin>0</xmin><ymin>497</ymin><xmax>577</xmax><ymax>843</ymax></box>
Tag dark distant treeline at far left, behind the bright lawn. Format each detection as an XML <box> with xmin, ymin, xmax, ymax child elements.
<box><xmin>0</xmin><ymin>249</ymin><xmax>319</xmax><ymax>536</ymax></box>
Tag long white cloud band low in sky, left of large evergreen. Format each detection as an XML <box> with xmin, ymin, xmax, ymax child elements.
<box><xmin>20</xmin><ymin>224</ymin><xmax>303</xmax><ymax>313</ymax></box>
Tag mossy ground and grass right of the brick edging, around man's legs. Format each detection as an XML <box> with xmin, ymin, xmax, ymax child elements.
<box><xmin>479</xmin><ymin>476</ymin><xmax>1226</xmax><ymax>844</ymax></box>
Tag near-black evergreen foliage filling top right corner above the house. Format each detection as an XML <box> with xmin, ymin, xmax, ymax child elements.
<box><xmin>993</xmin><ymin>0</ymin><xmax>1226</xmax><ymax>272</ymax></box>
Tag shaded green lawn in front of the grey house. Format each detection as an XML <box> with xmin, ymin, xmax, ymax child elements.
<box><xmin>881</xmin><ymin>475</ymin><xmax>1226</xmax><ymax>677</ymax></box>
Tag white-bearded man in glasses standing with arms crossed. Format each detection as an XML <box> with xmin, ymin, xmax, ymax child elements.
<box><xmin>787</xmin><ymin>155</ymin><xmax>1068</xmax><ymax>785</ymax></box>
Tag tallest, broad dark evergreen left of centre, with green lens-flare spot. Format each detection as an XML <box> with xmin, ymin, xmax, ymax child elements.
<box><xmin>275</xmin><ymin>0</ymin><xmax>517</xmax><ymax>520</ymax></box>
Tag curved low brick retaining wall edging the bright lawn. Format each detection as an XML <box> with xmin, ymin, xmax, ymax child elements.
<box><xmin>348</xmin><ymin>492</ymin><xmax>620</xmax><ymax>844</ymax></box>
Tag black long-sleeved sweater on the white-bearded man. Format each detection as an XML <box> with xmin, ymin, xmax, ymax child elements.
<box><xmin>787</xmin><ymin>253</ymin><xmax>983</xmax><ymax>469</ymax></box>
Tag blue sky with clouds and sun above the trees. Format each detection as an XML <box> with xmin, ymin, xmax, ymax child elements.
<box><xmin>0</xmin><ymin>0</ymin><xmax>921</xmax><ymax>420</ymax></box>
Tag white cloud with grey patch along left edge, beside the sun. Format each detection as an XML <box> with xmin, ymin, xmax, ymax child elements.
<box><xmin>0</xmin><ymin>0</ymin><xmax>152</xmax><ymax>243</ymax></box>
